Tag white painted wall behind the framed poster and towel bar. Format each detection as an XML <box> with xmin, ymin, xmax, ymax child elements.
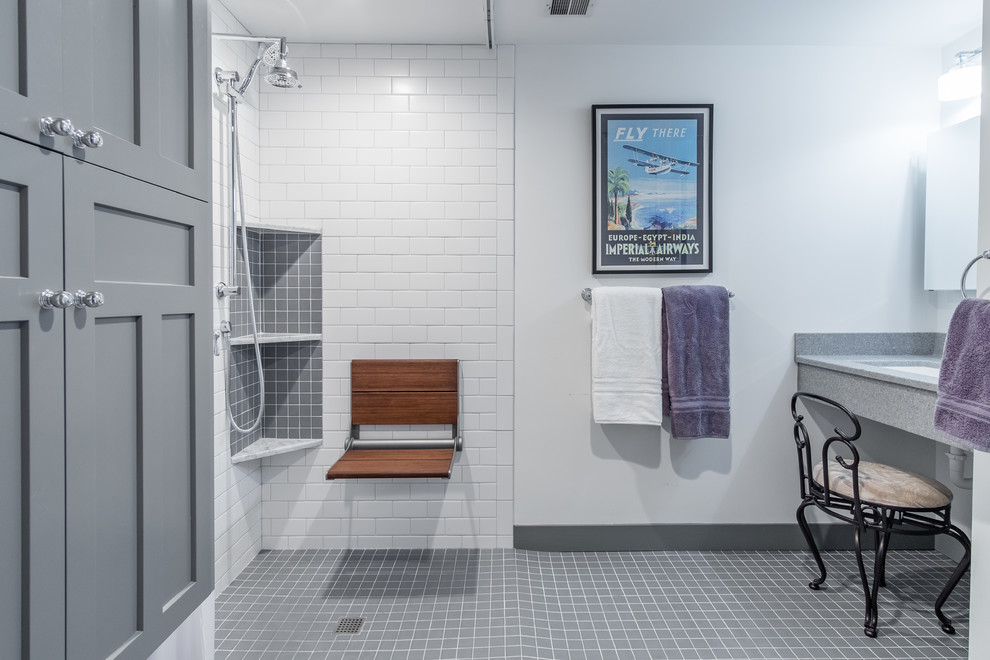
<box><xmin>515</xmin><ymin>46</ymin><xmax>940</xmax><ymax>525</ymax></box>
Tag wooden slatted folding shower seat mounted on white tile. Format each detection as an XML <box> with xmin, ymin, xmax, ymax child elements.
<box><xmin>327</xmin><ymin>360</ymin><xmax>462</xmax><ymax>479</ymax></box>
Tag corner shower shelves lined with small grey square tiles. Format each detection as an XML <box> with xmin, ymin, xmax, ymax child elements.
<box><xmin>228</xmin><ymin>226</ymin><xmax>323</xmax><ymax>463</ymax></box>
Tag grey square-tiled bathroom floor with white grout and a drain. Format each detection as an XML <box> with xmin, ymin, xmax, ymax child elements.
<box><xmin>216</xmin><ymin>550</ymin><xmax>969</xmax><ymax>660</ymax></box>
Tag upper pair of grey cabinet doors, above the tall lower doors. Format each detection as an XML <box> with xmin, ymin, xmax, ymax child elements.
<box><xmin>0</xmin><ymin>0</ymin><xmax>211</xmax><ymax>200</ymax></box>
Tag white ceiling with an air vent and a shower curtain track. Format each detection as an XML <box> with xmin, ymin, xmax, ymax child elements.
<box><xmin>220</xmin><ymin>0</ymin><xmax>982</xmax><ymax>46</ymax></box>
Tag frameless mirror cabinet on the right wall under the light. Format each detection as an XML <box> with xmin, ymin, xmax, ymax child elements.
<box><xmin>925</xmin><ymin>117</ymin><xmax>980</xmax><ymax>291</ymax></box>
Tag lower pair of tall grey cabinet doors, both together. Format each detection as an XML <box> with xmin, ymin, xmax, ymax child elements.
<box><xmin>0</xmin><ymin>137</ymin><xmax>213</xmax><ymax>660</ymax></box>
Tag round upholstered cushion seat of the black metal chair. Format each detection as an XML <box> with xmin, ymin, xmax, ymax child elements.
<box><xmin>813</xmin><ymin>461</ymin><xmax>952</xmax><ymax>509</ymax></box>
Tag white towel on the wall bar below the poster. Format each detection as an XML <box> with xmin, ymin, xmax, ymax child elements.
<box><xmin>591</xmin><ymin>287</ymin><xmax>663</xmax><ymax>426</ymax></box>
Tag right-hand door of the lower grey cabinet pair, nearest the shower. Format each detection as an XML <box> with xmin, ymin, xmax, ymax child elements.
<box><xmin>65</xmin><ymin>159</ymin><xmax>213</xmax><ymax>660</ymax></box>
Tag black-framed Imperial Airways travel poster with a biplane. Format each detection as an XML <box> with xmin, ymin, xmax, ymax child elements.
<box><xmin>591</xmin><ymin>104</ymin><xmax>712</xmax><ymax>273</ymax></box>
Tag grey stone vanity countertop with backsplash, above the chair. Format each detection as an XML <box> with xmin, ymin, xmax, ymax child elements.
<box><xmin>794</xmin><ymin>332</ymin><xmax>945</xmax><ymax>439</ymax></box>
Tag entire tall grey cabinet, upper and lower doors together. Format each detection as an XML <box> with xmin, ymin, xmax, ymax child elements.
<box><xmin>0</xmin><ymin>0</ymin><xmax>213</xmax><ymax>660</ymax></box>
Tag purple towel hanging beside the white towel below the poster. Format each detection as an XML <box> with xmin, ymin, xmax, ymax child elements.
<box><xmin>661</xmin><ymin>286</ymin><xmax>729</xmax><ymax>438</ymax></box>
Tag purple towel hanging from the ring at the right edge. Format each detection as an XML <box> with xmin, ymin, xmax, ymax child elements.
<box><xmin>935</xmin><ymin>298</ymin><xmax>990</xmax><ymax>451</ymax></box>
